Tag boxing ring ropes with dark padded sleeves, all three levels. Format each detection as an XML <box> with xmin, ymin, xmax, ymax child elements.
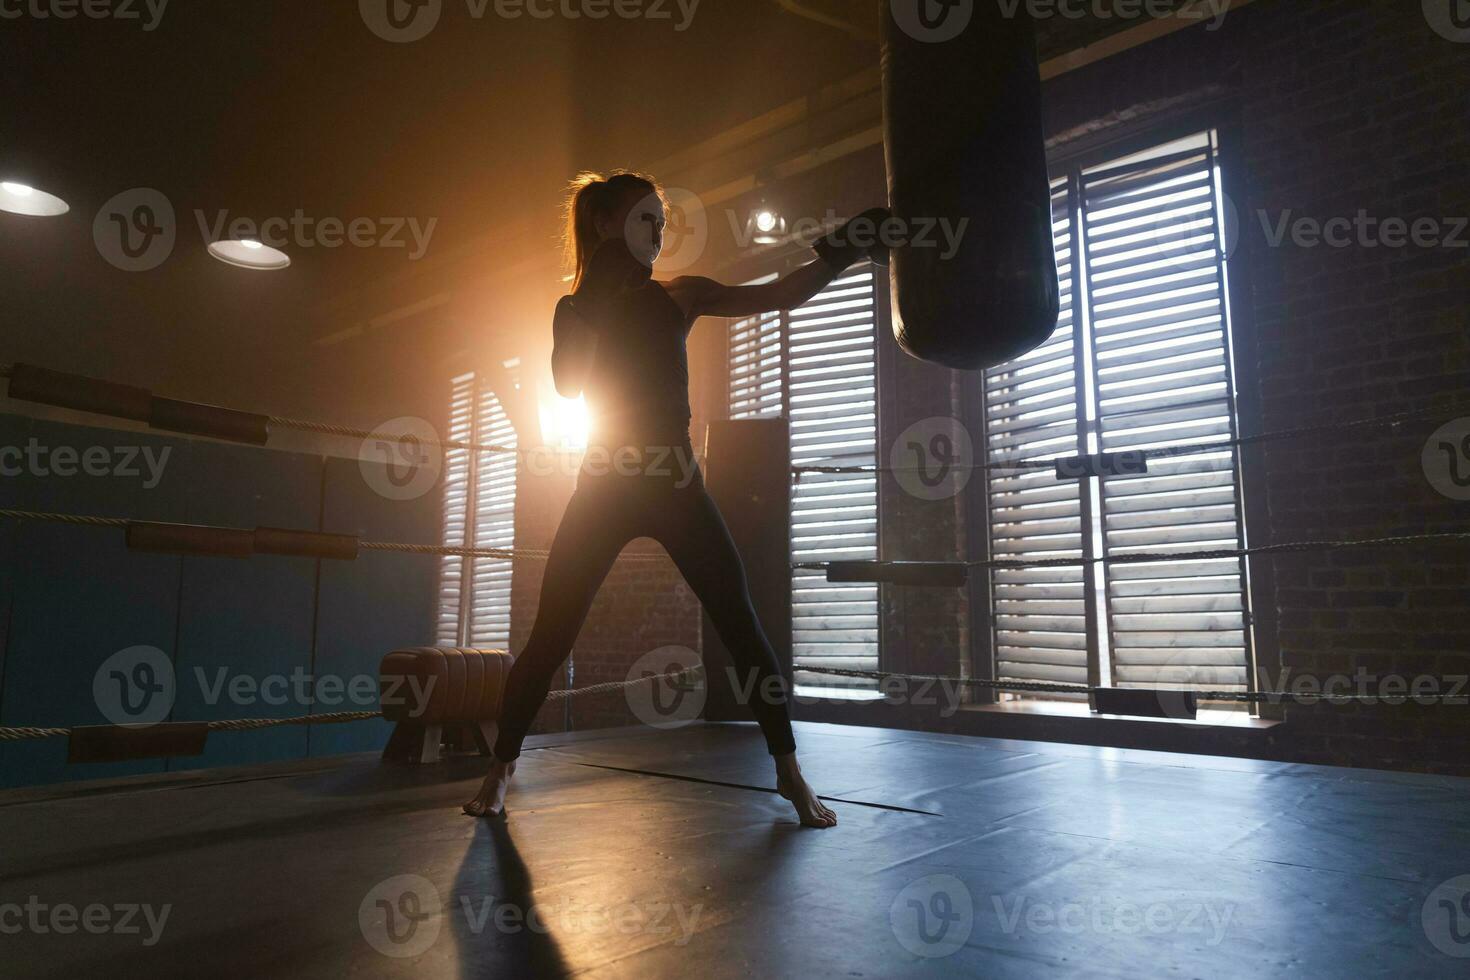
<box><xmin>0</xmin><ymin>363</ymin><xmax>1470</xmax><ymax>758</ymax></box>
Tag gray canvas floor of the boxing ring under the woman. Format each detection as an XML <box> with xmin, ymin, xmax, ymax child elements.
<box><xmin>0</xmin><ymin>724</ymin><xmax>1470</xmax><ymax>980</ymax></box>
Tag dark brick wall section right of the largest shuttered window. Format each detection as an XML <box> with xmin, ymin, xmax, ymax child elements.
<box><xmin>1238</xmin><ymin>1</ymin><xmax>1470</xmax><ymax>771</ymax></box>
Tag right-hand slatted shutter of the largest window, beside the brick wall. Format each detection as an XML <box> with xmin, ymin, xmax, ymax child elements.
<box><xmin>1080</xmin><ymin>134</ymin><xmax>1248</xmax><ymax>691</ymax></box>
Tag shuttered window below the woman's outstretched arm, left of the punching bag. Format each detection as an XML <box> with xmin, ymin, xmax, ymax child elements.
<box><xmin>729</xmin><ymin>264</ymin><xmax>878</xmax><ymax>685</ymax></box>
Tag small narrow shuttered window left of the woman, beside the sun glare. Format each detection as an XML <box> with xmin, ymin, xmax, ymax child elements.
<box><xmin>437</xmin><ymin>373</ymin><xmax>517</xmax><ymax>649</ymax></box>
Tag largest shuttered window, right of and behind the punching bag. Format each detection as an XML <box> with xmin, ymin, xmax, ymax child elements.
<box><xmin>985</xmin><ymin>132</ymin><xmax>1251</xmax><ymax>691</ymax></box>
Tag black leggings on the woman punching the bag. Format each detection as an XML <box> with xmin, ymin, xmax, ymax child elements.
<box><xmin>495</xmin><ymin>458</ymin><xmax>797</xmax><ymax>763</ymax></box>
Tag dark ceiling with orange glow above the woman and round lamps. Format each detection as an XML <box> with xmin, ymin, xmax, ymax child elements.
<box><xmin>0</xmin><ymin>0</ymin><xmax>1217</xmax><ymax>417</ymax></box>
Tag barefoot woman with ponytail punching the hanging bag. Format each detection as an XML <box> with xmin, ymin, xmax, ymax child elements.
<box><xmin>465</xmin><ymin>172</ymin><xmax>885</xmax><ymax>827</ymax></box>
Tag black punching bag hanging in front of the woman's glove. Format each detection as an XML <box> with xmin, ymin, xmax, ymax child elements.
<box><xmin>883</xmin><ymin>0</ymin><xmax>1058</xmax><ymax>370</ymax></box>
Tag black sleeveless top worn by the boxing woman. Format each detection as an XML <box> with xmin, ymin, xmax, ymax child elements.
<box><xmin>584</xmin><ymin>281</ymin><xmax>692</xmax><ymax>447</ymax></box>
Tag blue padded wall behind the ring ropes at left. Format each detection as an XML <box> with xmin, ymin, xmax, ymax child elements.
<box><xmin>0</xmin><ymin>416</ymin><xmax>441</xmax><ymax>786</ymax></box>
